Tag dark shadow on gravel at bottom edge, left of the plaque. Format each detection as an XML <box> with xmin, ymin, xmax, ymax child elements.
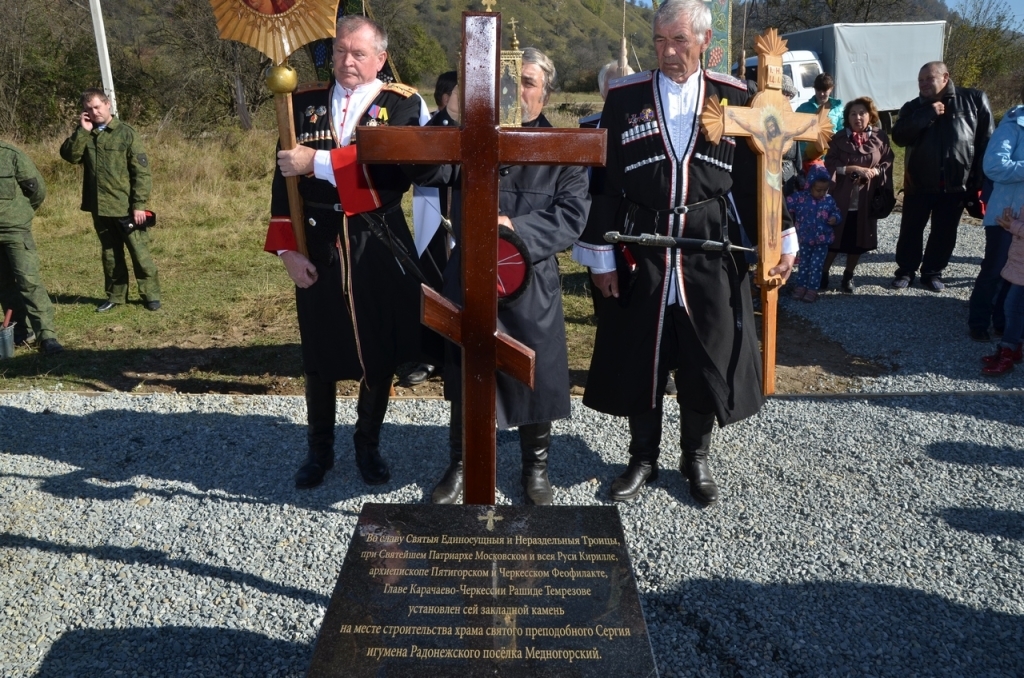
<box><xmin>35</xmin><ymin>626</ymin><xmax>312</xmax><ymax>678</ymax></box>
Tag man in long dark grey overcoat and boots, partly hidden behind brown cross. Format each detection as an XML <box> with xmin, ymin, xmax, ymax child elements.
<box><xmin>431</xmin><ymin>47</ymin><xmax>590</xmax><ymax>505</ymax></box>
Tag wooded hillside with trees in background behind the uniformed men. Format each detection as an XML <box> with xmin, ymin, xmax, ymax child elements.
<box><xmin>0</xmin><ymin>0</ymin><xmax>654</xmax><ymax>138</ymax></box>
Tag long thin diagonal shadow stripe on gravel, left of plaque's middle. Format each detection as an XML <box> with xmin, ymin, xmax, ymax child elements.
<box><xmin>0</xmin><ymin>533</ymin><xmax>331</xmax><ymax>607</ymax></box>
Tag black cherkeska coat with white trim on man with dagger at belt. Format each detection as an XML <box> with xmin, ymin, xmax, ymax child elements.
<box><xmin>578</xmin><ymin>72</ymin><xmax>788</xmax><ymax>424</ymax></box>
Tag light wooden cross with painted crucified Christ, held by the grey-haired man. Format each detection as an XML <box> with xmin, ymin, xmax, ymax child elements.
<box><xmin>700</xmin><ymin>29</ymin><xmax>833</xmax><ymax>395</ymax></box>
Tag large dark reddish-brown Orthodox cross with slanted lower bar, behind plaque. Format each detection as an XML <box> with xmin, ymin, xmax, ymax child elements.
<box><xmin>358</xmin><ymin>12</ymin><xmax>605</xmax><ymax>504</ymax></box>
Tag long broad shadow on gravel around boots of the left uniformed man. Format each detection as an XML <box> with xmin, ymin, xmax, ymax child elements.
<box><xmin>0</xmin><ymin>407</ymin><xmax>612</xmax><ymax>511</ymax></box>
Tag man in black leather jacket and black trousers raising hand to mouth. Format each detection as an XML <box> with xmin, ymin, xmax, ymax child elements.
<box><xmin>892</xmin><ymin>61</ymin><xmax>992</xmax><ymax>292</ymax></box>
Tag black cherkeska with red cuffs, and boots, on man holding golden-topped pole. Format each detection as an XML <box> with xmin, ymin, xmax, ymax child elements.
<box><xmin>264</xmin><ymin>83</ymin><xmax>425</xmax><ymax>488</ymax></box>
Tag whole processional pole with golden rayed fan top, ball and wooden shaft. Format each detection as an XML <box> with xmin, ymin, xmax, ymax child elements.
<box><xmin>210</xmin><ymin>0</ymin><xmax>338</xmax><ymax>254</ymax></box>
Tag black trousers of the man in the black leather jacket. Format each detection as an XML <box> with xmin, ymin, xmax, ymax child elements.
<box><xmin>896</xmin><ymin>193</ymin><xmax>967</xmax><ymax>279</ymax></box>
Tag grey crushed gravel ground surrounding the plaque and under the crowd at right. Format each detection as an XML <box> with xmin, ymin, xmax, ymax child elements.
<box><xmin>0</xmin><ymin>214</ymin><xmax>1024</xmax><ymax>678</ymax></box>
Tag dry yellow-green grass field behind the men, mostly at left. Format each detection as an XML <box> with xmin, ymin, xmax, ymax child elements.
<box><xmin>0</xmin><ymin>93</ymin><xmax>902</xmax><ymax>393</ymax></box>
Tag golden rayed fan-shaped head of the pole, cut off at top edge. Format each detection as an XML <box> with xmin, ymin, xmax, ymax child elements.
<box><xmin>210</xmin><ymin>0</ymin><xmax>338</xmax><ymax>66</ymax></box>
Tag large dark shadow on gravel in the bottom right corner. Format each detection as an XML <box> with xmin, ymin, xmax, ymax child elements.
<box><xmin>643</xmin><ymin>580</ymin><xmax>1024</xmax><ymax>677</ymax></box>
